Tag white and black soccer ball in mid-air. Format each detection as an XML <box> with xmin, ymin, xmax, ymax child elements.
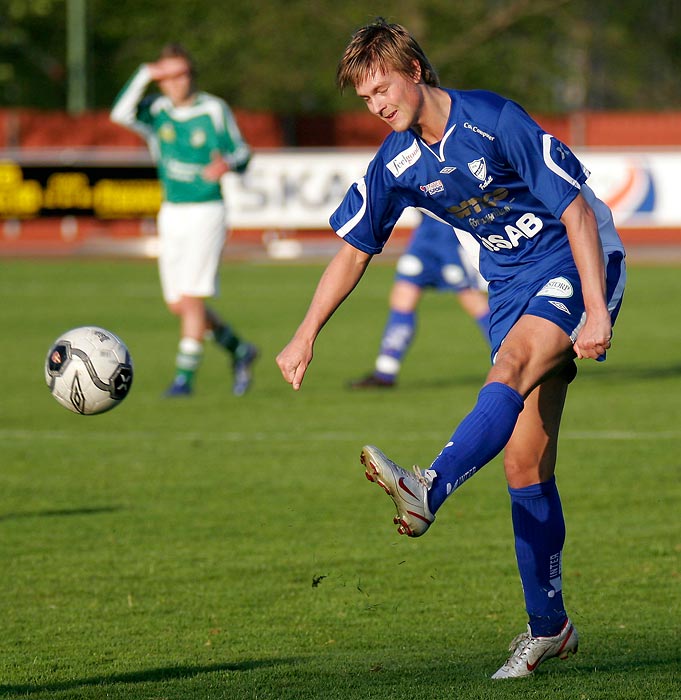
<box><xmin>45</xmin><ymin>326</ymin><xmax>133</xmax><ymax>415</ymax></box>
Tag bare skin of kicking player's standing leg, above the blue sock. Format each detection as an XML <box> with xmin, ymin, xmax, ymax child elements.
<box><xmin>504</xmin><ymin>375</ymin><xmax>568</xmax><ymax>488</ymax></box>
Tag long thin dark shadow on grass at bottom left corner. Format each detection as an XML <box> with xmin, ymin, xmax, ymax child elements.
<box><xmin>0</xmin><ymin>659</ymin><xmax>294</xmax><ymax>697</ymax></box>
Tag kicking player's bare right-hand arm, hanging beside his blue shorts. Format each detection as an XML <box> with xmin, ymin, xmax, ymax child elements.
<box><xmin>561</xmin><ymin>194</ymin><xmax>612</xmax><ymax>360</ymax></box>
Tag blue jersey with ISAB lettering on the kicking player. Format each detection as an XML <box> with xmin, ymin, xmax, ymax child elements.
<box><xmin>330</xmin><ymin>90</ymin><xmax>622</xmax><ymax>293</ymax></box>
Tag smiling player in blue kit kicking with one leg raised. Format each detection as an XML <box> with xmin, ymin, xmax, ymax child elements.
<box><xmin>277</xmin><ymin>19</ymin><xmax>625</xmax><ymax>679</ymax></box>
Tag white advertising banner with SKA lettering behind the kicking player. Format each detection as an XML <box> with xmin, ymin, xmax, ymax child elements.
<box><xmin>224</xmin><ymin>149</ymin><xmax>681</xmax><ymax>230</ymax></box>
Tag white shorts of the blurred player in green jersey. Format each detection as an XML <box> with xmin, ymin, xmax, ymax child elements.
<box><xmin>158</xmin><ymin>202</ymin><xmax>227</xmax><ymax>304</ymax></box>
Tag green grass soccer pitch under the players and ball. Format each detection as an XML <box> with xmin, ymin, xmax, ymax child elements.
<box><xmin>0</xmin><ymin>260</ymin><xmax>681</xmax><ymax>700</ymax></box>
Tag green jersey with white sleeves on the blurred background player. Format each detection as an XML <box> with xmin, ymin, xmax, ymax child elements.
<box><xmin>111</xmin><ymin>65</ymin><xmax>251</xmax><ymax>203</ymax></box>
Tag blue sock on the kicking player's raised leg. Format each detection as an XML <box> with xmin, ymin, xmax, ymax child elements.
<box><xmin>428</xmin><ymin>382</ymin><xmax>523</xmax><ymax>513</ymax></box>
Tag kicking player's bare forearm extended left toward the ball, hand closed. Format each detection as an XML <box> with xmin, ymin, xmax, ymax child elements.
<box><xmin>277</xmin><ymin>243</ymin><xmax>371</xmax><ymax>391</ymax></box>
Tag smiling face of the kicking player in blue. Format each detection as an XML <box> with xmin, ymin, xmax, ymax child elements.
<box><xmin>355</xmin><ymin>70</ymin><xmax>423</xmax><ymax>131</ymax></box>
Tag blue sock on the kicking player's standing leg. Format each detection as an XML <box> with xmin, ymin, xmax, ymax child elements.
<box><xmin>508</xmin><ymin>477</ymin><xmax>567</xmax><ymax>637</ymax></box>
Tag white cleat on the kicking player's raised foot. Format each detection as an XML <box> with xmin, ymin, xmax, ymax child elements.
<box><xmin>360</xmin><ymin>445</ymin><xmax>435</xmax><ymax>537</ymax></box>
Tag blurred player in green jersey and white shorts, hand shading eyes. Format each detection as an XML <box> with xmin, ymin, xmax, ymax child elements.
<box><xmin>111</xmin><ymin>44</ymin><xmax>258</xmax><ymax>397</ymax></box>
